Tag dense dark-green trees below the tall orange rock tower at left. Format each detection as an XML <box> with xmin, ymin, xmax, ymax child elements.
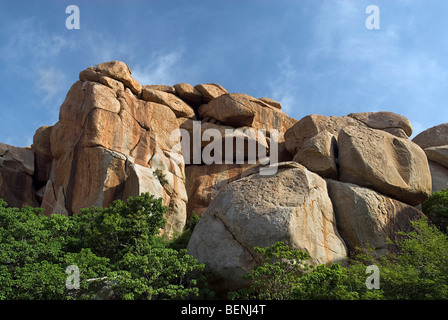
<box><xmin>0</xmin><ymin>194</ymin><xmax>204</xmax><ymax>299</ymax></box>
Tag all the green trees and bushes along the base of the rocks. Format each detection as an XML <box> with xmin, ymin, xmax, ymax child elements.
<box><xmin>0</xmin><ymin>190</ymin><xmax>448</xmax><ymax>300</ymax></box>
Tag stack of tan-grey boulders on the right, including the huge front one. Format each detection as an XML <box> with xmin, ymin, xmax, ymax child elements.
<box><xmin>188</xmin><ymin>112</ymin><xmax>431</xmax><ymax>291</ymax></box>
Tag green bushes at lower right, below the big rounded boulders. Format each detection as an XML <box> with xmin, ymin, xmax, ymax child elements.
<box><xmin>229</xmin><ymin>218</ymin><xmax>448</xmax><ymax>300</ymax></box>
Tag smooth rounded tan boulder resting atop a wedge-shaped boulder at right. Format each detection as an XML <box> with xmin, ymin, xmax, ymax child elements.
<box><xmin>338</xmin><ymin>126</ymin><xmax>431</xmax><ymax>205</ymax></box>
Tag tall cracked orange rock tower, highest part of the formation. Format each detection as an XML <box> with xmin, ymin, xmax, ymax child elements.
<box><xmin>42</xmin><ymin>63</ymin><xmax>191</xmax><ymax>234</ymax></box>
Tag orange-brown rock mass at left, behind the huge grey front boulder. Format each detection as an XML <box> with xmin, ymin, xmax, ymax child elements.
<box><xmin>0</xmin><ymin>61</ymin><xmax>297</xmax><ymax>235</ymax></box>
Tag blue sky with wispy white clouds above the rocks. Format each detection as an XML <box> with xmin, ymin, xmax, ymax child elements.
<box><xmin>0</xmin><ymin>0</ymin><xmax>448</xmax><ymax>147</ymax></box>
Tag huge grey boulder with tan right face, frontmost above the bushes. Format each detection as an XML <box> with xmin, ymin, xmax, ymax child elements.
<box><xmin>187</xmin><ymin>162</ymin><xmax>347</xmax><ymax>290</ymax></box>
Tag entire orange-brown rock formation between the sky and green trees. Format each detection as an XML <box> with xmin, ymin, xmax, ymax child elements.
<box><xmin>0</xmin><ymin>61</ymin><xmax>442</xmax><ymax>296</ymax></box>
